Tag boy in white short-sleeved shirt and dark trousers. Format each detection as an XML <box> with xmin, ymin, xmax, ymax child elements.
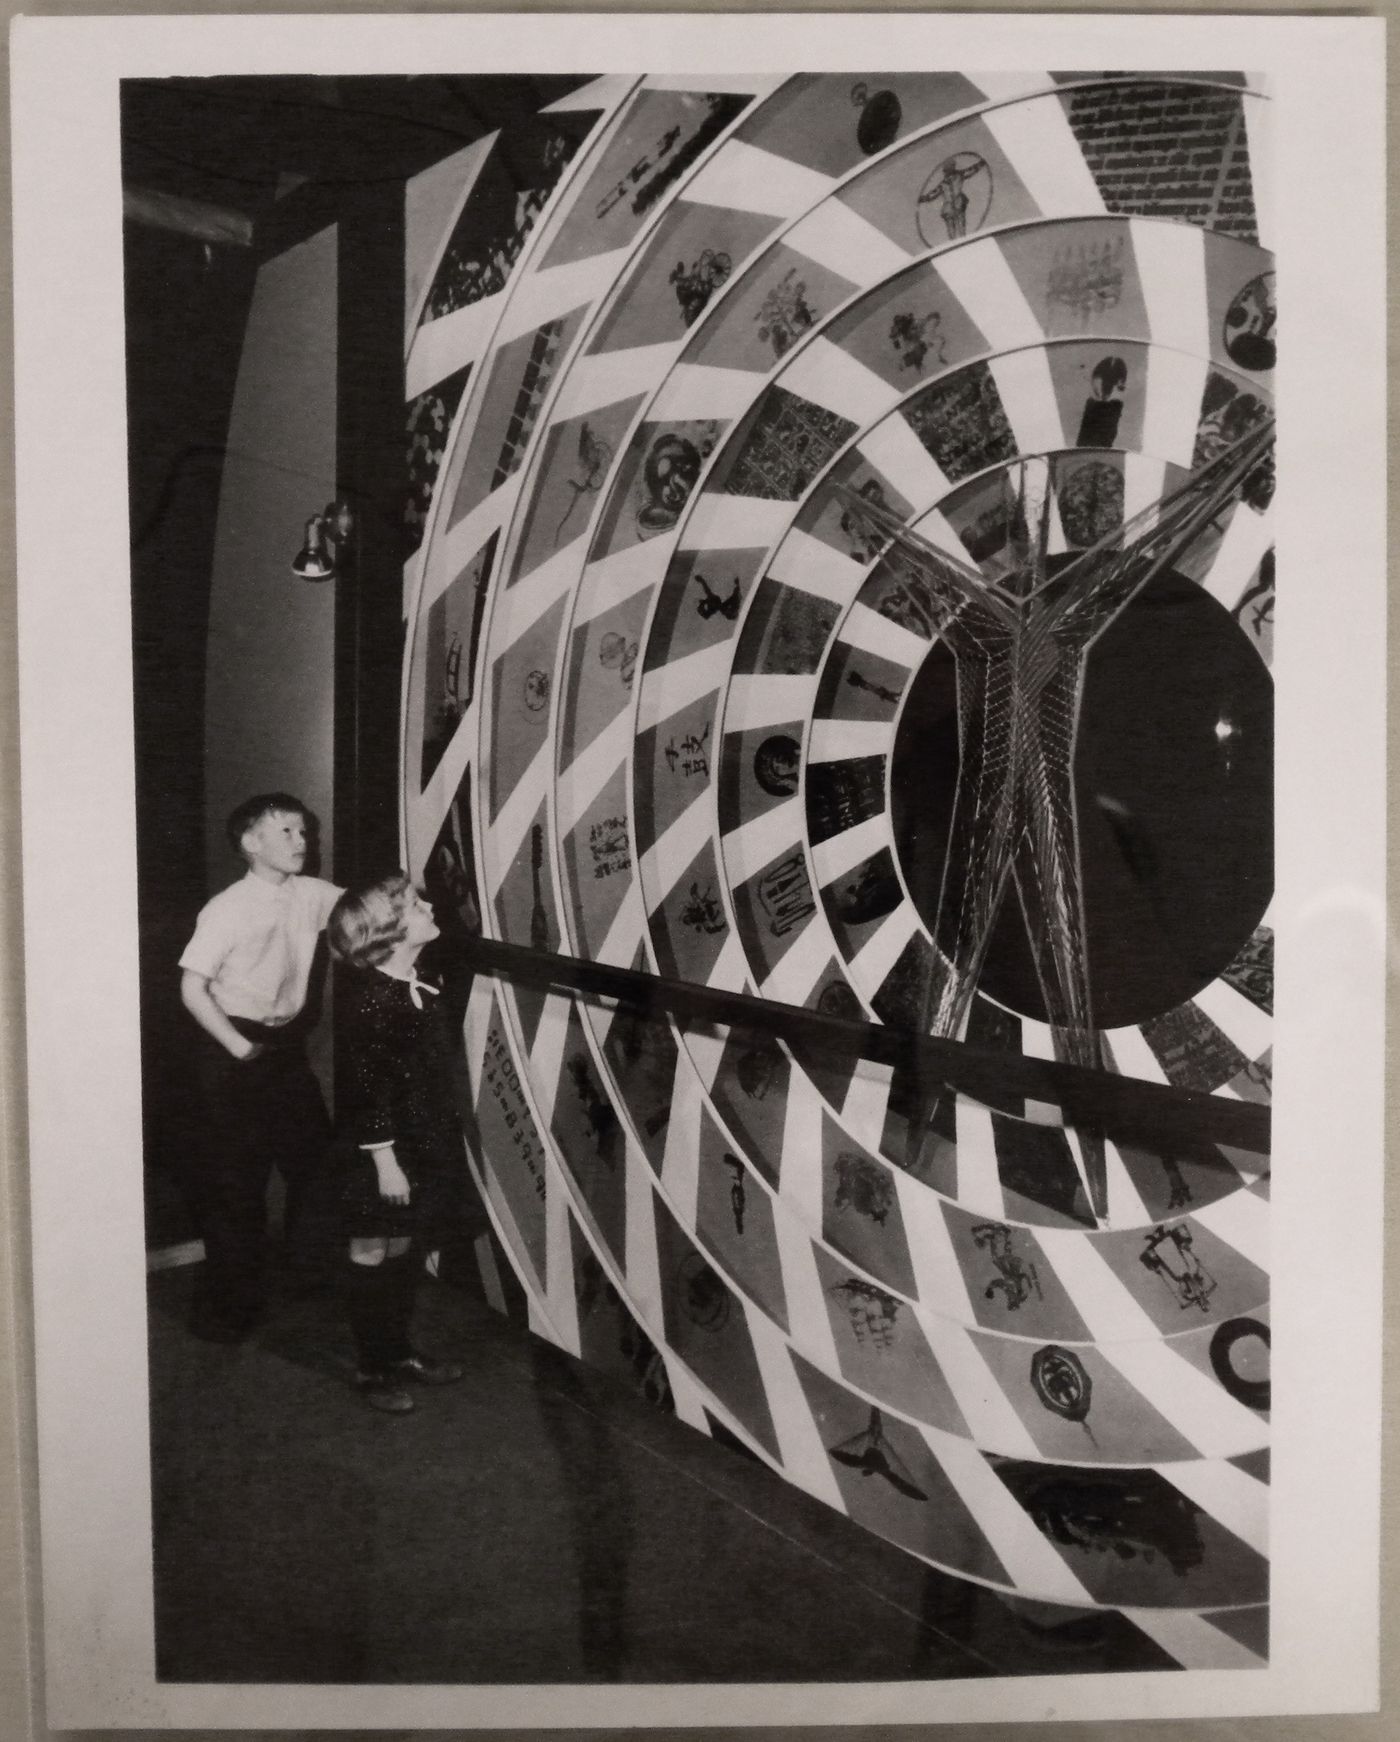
<box><xmin>179</xmin><ymin>793</ymin><xmax>341</xmax><ymax>1343</ymax></box>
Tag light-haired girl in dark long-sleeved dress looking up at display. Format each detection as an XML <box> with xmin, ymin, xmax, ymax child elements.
<box><xmin>326</xmin><ymin>874</ymin><xmax>463</xmax><ymax>1415</ymax></box>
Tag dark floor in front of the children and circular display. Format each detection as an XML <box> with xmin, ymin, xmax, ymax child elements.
<box><xmin>150</xmin><ymin>1266</ymin><xmax>1184</xmax><ymax>1683</ymax></box>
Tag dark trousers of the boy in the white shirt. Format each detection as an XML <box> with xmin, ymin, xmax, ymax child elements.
<box><xmin>195</xmin><ymin>1017</ymin><xmax>331</xmax><ymax>1340</ymax></box>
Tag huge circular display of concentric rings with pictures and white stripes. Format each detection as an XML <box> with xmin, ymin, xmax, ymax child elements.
<box><xmin>402</xmin><ymin>71</ymin><xmax>1276</xmax><ymax>1669</ymax></box>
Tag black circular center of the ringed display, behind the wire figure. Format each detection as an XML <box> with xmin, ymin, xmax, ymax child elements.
<box><xmin>892</xmin><ymin>573</ymin><xmax>1273</xmax><ymax>1028</ymax></box>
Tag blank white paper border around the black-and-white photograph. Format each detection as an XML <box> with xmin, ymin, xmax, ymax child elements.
<box><xmin>12</xmin><ymin>14</ymin><xmax>1388</xmax><ymax>1730</ymax></box>
